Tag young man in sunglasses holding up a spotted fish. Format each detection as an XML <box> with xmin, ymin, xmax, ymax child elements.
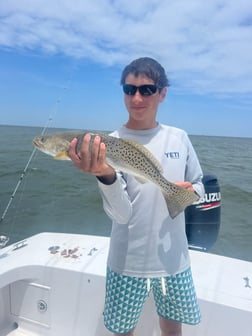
<box><xmin>69</xmin><ymin>57</ymin><xmax>204</xmax><ymax>336</ymax></box>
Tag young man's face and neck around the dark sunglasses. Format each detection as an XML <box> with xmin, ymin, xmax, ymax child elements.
<box><xmin>124</xmin><ymin>74</ymin><xmax>166</xmax><ymax>129</ymax></box>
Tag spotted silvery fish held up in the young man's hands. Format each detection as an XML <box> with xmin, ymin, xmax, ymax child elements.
<box><xmin>33</xmin><ymin>131</ymin><xmax>199</xmax><ymax>218</ymax></box>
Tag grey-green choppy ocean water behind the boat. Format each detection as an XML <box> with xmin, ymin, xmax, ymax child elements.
<box><xmin>0</xmin><ymin>125</ymin><xmax>252</xmax><ymax>261</ymax></box>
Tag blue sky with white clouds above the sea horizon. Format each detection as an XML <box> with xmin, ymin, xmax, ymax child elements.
<box><xmin>0</xmin><ymin>0</ymin><xmax>252</xmax><ymax>137</ymax></box>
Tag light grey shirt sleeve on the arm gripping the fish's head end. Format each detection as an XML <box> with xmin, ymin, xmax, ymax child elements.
<box><xmin>98</xmin><ymin>172</ymin><xmax>132</xmax><ymax>224</ymax></box>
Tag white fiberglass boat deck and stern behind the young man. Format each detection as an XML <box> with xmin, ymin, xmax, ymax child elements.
<box><xmin>0</xmin><ymin>233</ymin><xmax>252</xmax><ymax>336</ymax></box>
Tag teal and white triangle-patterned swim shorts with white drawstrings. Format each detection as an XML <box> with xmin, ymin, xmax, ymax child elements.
<box><xmin>104</xmin><ymin>268</ymin><xmax>200</xmax><ymax>333</ymax></box>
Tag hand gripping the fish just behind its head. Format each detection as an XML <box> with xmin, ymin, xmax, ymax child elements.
<box><xmin>68</xmin><ymin>134</ymin><xmax>116</xmax><ymax>184</ymax></box>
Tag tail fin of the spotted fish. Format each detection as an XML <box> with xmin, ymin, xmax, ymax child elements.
<box><xmin>163</xmin><ymin>184</ymin><xmax>199</xmax><ymax>219</ymax></box>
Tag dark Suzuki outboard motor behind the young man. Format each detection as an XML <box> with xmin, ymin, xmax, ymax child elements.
<box><xmin>185</xmin><ymin>175</ymin><xmax>221</xmax><ymax>251</ymax></box>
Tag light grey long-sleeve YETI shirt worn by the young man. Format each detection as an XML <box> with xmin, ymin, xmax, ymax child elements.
<box><xmin>98</xmin><ymin>124</ymin><xmax>204</xmax><ymax>278</ymax></box>
